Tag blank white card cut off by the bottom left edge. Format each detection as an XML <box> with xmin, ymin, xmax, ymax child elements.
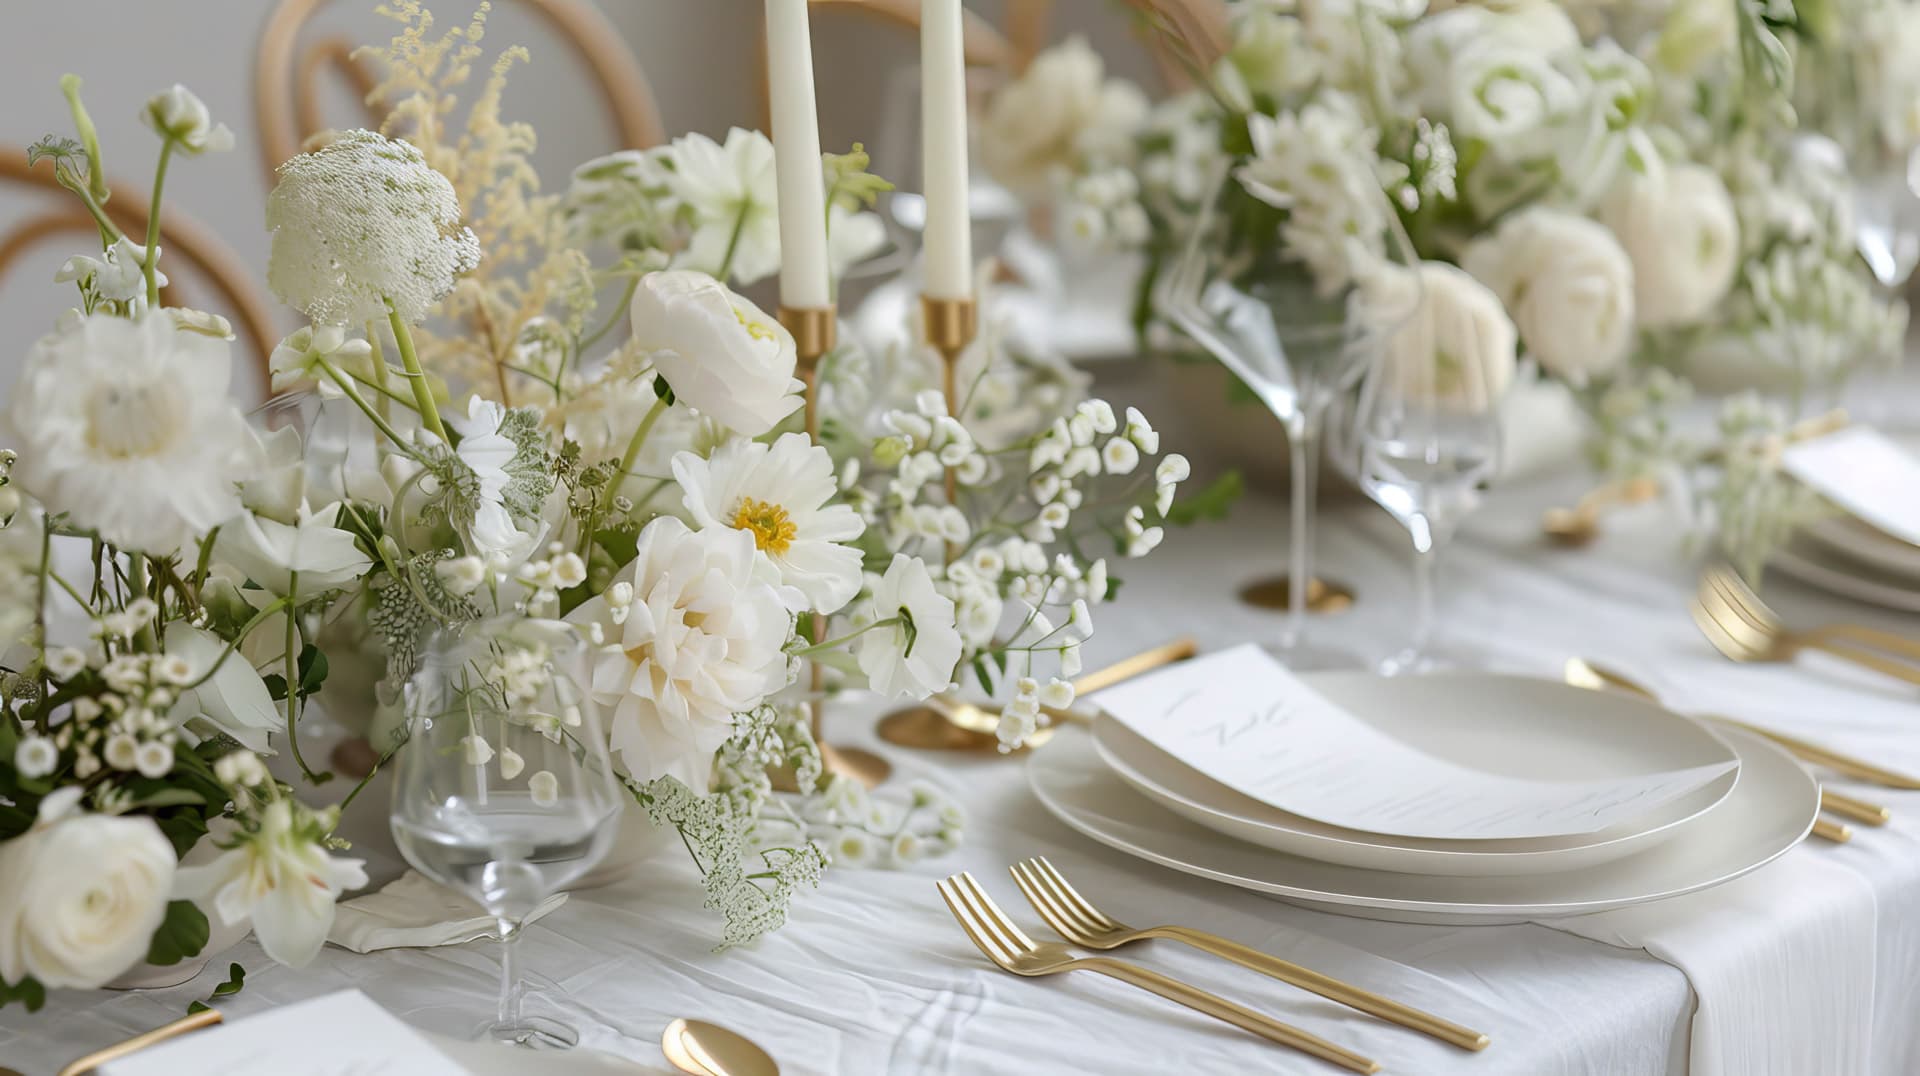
<box><xmin>100</xmin><ymin>990</ymin><xmax>467</xmax><ymax>1076</ymax></box>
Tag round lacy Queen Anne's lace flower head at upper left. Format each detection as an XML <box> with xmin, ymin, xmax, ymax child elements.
<box><xmin>267</xmin><ymin>131</ymin><xmax>480</xmax><ymax>325</ymax></box>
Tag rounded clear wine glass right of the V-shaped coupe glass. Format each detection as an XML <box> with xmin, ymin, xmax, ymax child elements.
<box><xmin>1350</xmin><ymin>317</ymin><xmax>1509</xmax><ymax>676</ymax></box>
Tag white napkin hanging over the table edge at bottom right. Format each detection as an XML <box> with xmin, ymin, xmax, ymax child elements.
<box><xmin>1544</xmin><ymin>842</ymin><xmax>1880</xmax><ymax>1076</ymax></box>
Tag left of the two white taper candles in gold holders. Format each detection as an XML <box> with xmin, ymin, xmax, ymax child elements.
<box><xmin>766</xmin><ymin>0</ymin><xmax>833</xmax><ymax>309</ymax></box>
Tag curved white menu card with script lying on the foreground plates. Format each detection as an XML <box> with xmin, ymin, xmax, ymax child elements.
<box><xmin>1092</xmin><ymin>646</ymin><xmax>1740</xmax><ymax>840</ymax></box>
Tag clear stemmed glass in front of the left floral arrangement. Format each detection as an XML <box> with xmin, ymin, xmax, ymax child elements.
<box><xmin>392</xmin><ymin>617</ymin><xmax>620</xmax><ymax>1049</ymax></box>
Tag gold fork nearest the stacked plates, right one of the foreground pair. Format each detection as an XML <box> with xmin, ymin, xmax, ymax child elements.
<box><xmin>1008</xmin><ymin>855</ymin><xmax>1490</xmax><ymax>1049</ymax></box>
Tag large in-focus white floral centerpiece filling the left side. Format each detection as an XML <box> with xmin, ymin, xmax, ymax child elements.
<box><xmin>0</xmin><ymin>2</ymin><xmax>1187</xmax><ymax>1007</ymax></box>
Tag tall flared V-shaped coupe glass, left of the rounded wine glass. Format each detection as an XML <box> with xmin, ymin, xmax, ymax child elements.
<box><xmin>1154</xmin><ymin>175</ymin><xmax>1421</xmax><ymax>669</ymax></box>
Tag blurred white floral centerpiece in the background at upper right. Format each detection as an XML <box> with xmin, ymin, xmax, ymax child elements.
<box><xmin>983</xmin><ymin>0</ymin><xmax>1920</xmax><ymax>561</ymax></box>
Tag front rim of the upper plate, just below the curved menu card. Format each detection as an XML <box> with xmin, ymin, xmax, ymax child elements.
<box><xmin>1094</xmin><ymin>691</ymin><xmax>1740</xmax><ymax>876</ymax></box>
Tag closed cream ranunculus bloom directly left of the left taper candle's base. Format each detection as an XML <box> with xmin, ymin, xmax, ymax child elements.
<box><xmin>630</xmin><ymin>269</ymin><xmax>803</xmax><ymax>436</ymax></box>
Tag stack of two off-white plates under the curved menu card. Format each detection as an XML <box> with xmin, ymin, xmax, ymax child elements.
<box><xmin>1027</xmin><ymin>673</ymin><xmax>1820</xmax><ymax>922</ymax></box>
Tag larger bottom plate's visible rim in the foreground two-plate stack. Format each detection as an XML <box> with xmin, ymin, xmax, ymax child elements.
<box><xmin>1027</xmin><ymin>726</ymin><xmax>1820</xmax><ymax>924</ymax></box>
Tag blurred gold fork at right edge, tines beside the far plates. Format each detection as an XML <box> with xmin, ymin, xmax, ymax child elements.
<box><xmin>1692</xmin><ymin>565</ymin><xmax>1920</xmax><ymax>684</ymax></box>
